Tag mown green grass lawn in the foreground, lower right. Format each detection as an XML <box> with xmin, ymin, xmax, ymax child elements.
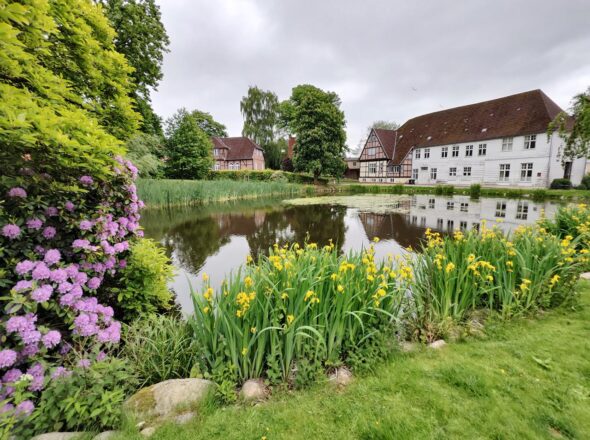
<box><xmin>115</xmin><ymin>282</ymin><xmax>590</xmax><ymax>440</ymax></box>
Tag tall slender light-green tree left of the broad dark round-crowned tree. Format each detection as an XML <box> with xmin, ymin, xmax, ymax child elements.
<box><xmin>240</xmin><ymin>86</ymin><xmax>281</xmax><ymax>169</ymax></box>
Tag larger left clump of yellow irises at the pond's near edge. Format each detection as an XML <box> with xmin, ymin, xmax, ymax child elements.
<box><xmin>191</xmin><ymin>243</ymin><xmax>412</xmax><ymax>380</ymax></box>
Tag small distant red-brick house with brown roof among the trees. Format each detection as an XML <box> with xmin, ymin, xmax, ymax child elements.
<box><xmin>212</xmin><ymin>137</ymin><xmax>264</xmax><ymax>170</ymax></box>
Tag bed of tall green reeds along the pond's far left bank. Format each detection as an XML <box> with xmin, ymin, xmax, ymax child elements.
<box><xmin>137</xmin><ymin>179</ymin><xmax>315</xmax><ymax>208</ymax></box>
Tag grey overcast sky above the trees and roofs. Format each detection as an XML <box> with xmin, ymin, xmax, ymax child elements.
<box><xmin>153</xmin><ymin>0</ymin><xmax>590</xmax><ymax>152</ymax></box>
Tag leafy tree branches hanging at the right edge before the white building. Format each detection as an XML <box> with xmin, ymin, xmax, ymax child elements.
<box><xmin>548</xmin><ymin>87</ymin><xmax>590</xmax><ymax>162</ymax></box>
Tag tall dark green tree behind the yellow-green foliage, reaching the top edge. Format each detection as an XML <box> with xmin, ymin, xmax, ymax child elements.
<box><xmin>98</xmin><ymin>0</ymin><xmax>170</xmax><ymax>134</ymax></box>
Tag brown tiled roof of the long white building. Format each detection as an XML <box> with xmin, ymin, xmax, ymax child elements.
<box><xmin>375</xmin><ymin>90</ymin><xmax>562</xmax><ymax>164</ymax></box>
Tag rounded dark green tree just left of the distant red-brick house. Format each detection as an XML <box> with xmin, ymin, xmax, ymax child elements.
<box><xmin>165</xmin><ymin>108</ymin><xmax>213</xmax><ymax>179</ymax></box>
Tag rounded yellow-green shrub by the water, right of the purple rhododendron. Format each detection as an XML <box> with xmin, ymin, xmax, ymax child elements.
<box><xmin>113</xmin><ymin>238</ymin><xmax>174</xmax><ymax>322</ymax></box>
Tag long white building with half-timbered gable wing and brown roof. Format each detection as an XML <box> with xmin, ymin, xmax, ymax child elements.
<box><xmin>359</xmin><ymin>90</ymin><xmax>586</xmax><ymax>187</ymax></box>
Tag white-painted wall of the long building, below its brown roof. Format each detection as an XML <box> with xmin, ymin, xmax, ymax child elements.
<box><xmin>412</xmin><ymin>133</ymin><xmax>586</xmax><ymax>188</ymax></box>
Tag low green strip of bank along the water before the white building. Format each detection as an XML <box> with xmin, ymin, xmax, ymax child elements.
<box><xmin>332</xmin><ymin>183</ymin><xmax>590</xmax><ymax>199</ymax></box>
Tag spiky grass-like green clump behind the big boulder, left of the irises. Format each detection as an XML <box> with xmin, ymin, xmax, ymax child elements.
<box><xmin>121</xmin><ymin>316</ymin><xmax>196</xmax><ymax>387</ymax></box>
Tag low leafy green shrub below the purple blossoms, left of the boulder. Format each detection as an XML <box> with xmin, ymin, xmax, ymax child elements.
<box><xmin>22</xmin><ymin>357</ymin><xmax>137</xmax><ymax>438</ymax></box>
